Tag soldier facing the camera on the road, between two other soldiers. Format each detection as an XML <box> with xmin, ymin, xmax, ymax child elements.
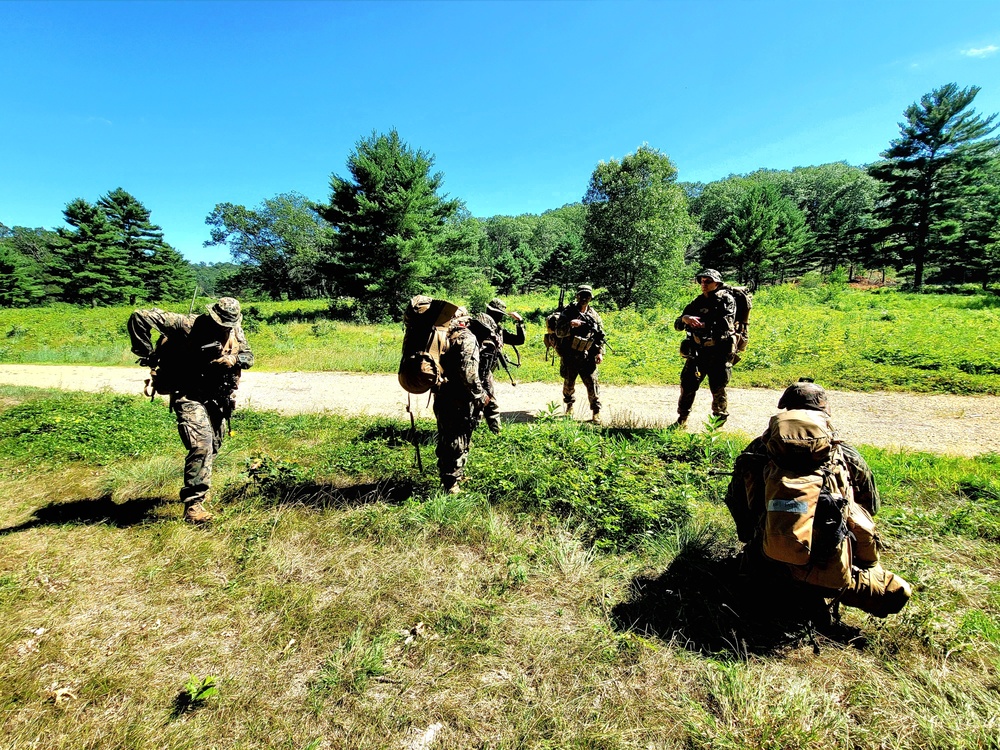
<box><xmin>556</xmin><ymin>284</ymin><xmax>604</xmax><ymax>424</ymax></box>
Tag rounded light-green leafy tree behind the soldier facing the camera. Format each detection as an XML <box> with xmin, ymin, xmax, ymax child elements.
<box><xmin>583</xmin><ymin>145</ymin><xmax>695</xmax><ymax>307</ymax></box>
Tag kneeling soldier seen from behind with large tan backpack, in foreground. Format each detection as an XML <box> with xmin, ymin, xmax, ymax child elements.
<box><xmin>726</xmin><ymin>381</ymin><xmax>912</xmax><ymax>617</ymax></box>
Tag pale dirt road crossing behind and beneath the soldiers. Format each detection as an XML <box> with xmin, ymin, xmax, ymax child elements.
<box><xmin>0</xmin><ymin>365</ymin><xmax>1000</xmax><ymax>456</ymax></box>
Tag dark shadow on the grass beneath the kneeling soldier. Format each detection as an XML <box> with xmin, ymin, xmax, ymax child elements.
<box><xmin>612</xmin><ymin>537</ymin><xmax>864</xmax><ymax>656</ymax></box>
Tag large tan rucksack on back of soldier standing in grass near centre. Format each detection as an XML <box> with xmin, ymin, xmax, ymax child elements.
<box><xmin>399</xmin><ymin>294</ymin><xmax>462</xmax><ymax>393</ymax></box>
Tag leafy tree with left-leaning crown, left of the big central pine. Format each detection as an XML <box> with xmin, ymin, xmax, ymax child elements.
<box><xmin>205</xmin><ymin>193</ymin><xmax>332</xmax><ymax>299</ymax></box>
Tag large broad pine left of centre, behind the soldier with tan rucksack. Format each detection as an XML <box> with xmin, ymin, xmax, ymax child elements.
<box><xmin>318</xmin><ymin>130</ymin><xmax>460</xmax><ymax>318</ymax></box>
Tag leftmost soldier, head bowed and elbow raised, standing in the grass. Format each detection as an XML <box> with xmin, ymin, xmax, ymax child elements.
<box><xmin>128</xmin><ymin>297</ymin><xmax>253</xmax><ymax>524</ymax></box>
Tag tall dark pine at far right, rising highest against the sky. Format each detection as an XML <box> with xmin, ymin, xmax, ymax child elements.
<box><xmin>871</xmin><ymin>83</ymin><xmax>998</xmax><ymax>289</ymax></box>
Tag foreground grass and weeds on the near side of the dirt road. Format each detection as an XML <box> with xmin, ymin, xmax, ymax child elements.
<box><xmin>0</xmin><ymin>388</ymin><xmax>1000</xmax><ymax>750</ymax></box>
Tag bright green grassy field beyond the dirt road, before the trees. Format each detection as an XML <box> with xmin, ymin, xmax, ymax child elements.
<box><xmin>0</xmin><ymin>285</ymin><xmax>1000</xmax><ymax>395</ymax></box>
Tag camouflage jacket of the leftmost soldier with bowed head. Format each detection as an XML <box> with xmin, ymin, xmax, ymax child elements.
<box><xmin>128</xmin><ymin>309</ymin><xmax>253</xmax><ymax>401</ymax></box>
